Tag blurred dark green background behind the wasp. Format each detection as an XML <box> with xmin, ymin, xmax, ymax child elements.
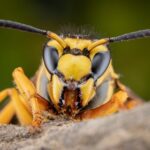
<box><xmin>0</xmin><ymin>0</ymin><xmax>150</xmax><ymax>100</ymax></box>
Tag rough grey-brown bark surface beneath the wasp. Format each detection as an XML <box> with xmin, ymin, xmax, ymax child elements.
<box><xmin>0</xmin><ymin>103</ymin><xmax>150</xmax><ymax>150</ymax></box>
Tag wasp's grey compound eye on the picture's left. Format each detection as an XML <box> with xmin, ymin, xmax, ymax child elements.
<box><xmin>43</xmin><ymin>46</ymin><xmax>59</xmax><ymax>73</ymax></box>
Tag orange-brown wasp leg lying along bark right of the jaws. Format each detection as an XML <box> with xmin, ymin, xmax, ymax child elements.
<box><xmin>77</xmin><ymin>90</ymin><xmax>128</xmax><ymax>120</ymax></box>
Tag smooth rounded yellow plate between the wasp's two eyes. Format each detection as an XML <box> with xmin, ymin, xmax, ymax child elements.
<box><xmin>57</xmin><ymin>54</ymin><xmax>91</xmax><ymax>81</ymax></box>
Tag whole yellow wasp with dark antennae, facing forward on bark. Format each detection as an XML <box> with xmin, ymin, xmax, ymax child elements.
<box><xmin>0</xmin><ymin>20</ymin><xmax>150</xmax><ymax>126</ymax></box>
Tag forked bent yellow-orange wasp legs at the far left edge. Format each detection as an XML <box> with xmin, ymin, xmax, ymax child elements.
<box><xmin>0</xmin><ymin>88</ymin><xmax>32</xmax><ymax>125</ymax></box>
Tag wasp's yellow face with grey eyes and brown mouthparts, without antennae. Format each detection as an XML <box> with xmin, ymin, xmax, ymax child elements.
<box><xmin>43</xmin><ymin>38</ymin><xmax>110</xmax><ymax>115</ymax></box>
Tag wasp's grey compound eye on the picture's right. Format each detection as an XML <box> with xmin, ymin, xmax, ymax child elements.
<box><xmin>92</xmin><ymin>51</ymin><xmax>111</xmax><ymax>80</ymax></box>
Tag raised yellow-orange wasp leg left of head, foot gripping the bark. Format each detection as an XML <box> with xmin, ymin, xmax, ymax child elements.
<box><xmin>13</xmin><ymin>67</ymin><xmax>49</xmax><ymax>127</ymax></box>
